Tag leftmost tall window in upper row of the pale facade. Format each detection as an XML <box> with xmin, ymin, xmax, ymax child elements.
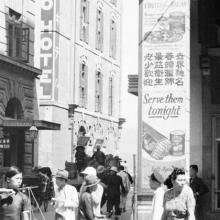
<box><xmin>80</xmin><ymin>0</ymin><xmax>89</xmax><ymax>43</ymax></box>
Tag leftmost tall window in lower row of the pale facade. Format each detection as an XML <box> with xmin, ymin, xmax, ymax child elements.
<box><xmin>79</xmin><ymin>62</ymin><xmax>88</xmax><ymax>108</ymax></box>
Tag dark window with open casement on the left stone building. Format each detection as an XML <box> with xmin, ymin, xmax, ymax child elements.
<box><xmin>7</xmin><ymin>9</ymin><xmax>30</xmax><ymax>62</ymax></box>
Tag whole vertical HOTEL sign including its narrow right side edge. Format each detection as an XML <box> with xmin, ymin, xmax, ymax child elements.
<box><xmin>40</xmin><ymin>0</ymin><xmax>60</xmax><ymax>100</ymax></box>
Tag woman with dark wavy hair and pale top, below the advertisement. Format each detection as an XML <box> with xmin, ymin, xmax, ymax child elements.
<box><xmin>162</xmin><ymin>168</ymin><xmax>195</xmax><ymax>220</ymax></box>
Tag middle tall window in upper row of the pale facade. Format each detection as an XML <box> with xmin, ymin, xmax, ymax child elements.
<box><xmin>96</xmin><ymin>9</ymin><xmax>103</xmax><ymax>52</ymax></box>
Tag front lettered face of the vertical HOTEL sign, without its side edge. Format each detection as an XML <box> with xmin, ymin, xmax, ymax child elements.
<box><xmin>40</xmin><ymin>0</ymin><xmax>54</xmax><ymax>100</ymax></box>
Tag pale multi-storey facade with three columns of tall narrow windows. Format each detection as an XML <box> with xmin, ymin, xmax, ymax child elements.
<box><xmin>74</xmin><ymin>0</ymin><xmax>122</xmax><ymax>155</ymax></box>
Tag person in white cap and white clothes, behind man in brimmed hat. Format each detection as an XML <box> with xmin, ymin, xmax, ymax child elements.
<box><xmin>80</xmin><ymin>167</ymin><xmax>104</xmax><ymax>218</ymax></box>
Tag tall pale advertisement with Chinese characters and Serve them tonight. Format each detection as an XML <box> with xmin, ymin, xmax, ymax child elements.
<box><xmin>138</xmin><ymin>0</ymin><xmax>190</xmax><ymax>192</ymax></box>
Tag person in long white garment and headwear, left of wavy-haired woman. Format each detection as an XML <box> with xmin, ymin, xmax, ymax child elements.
<box><xmin>150</xmin><ymin>170</ymin><xmax>165</xmax><ymax>220</ymax></box>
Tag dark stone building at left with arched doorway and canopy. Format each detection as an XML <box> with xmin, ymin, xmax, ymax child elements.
<box><xmin>0</xmin><ymin>1</ymin><xmax>59</xmax><ymax>174</ymax></box>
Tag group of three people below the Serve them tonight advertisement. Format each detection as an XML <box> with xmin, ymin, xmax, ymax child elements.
<box><xmin>150</xmin><ymin>164</ymin><xmax>209</xmax><ymax>220</ymax></box>
